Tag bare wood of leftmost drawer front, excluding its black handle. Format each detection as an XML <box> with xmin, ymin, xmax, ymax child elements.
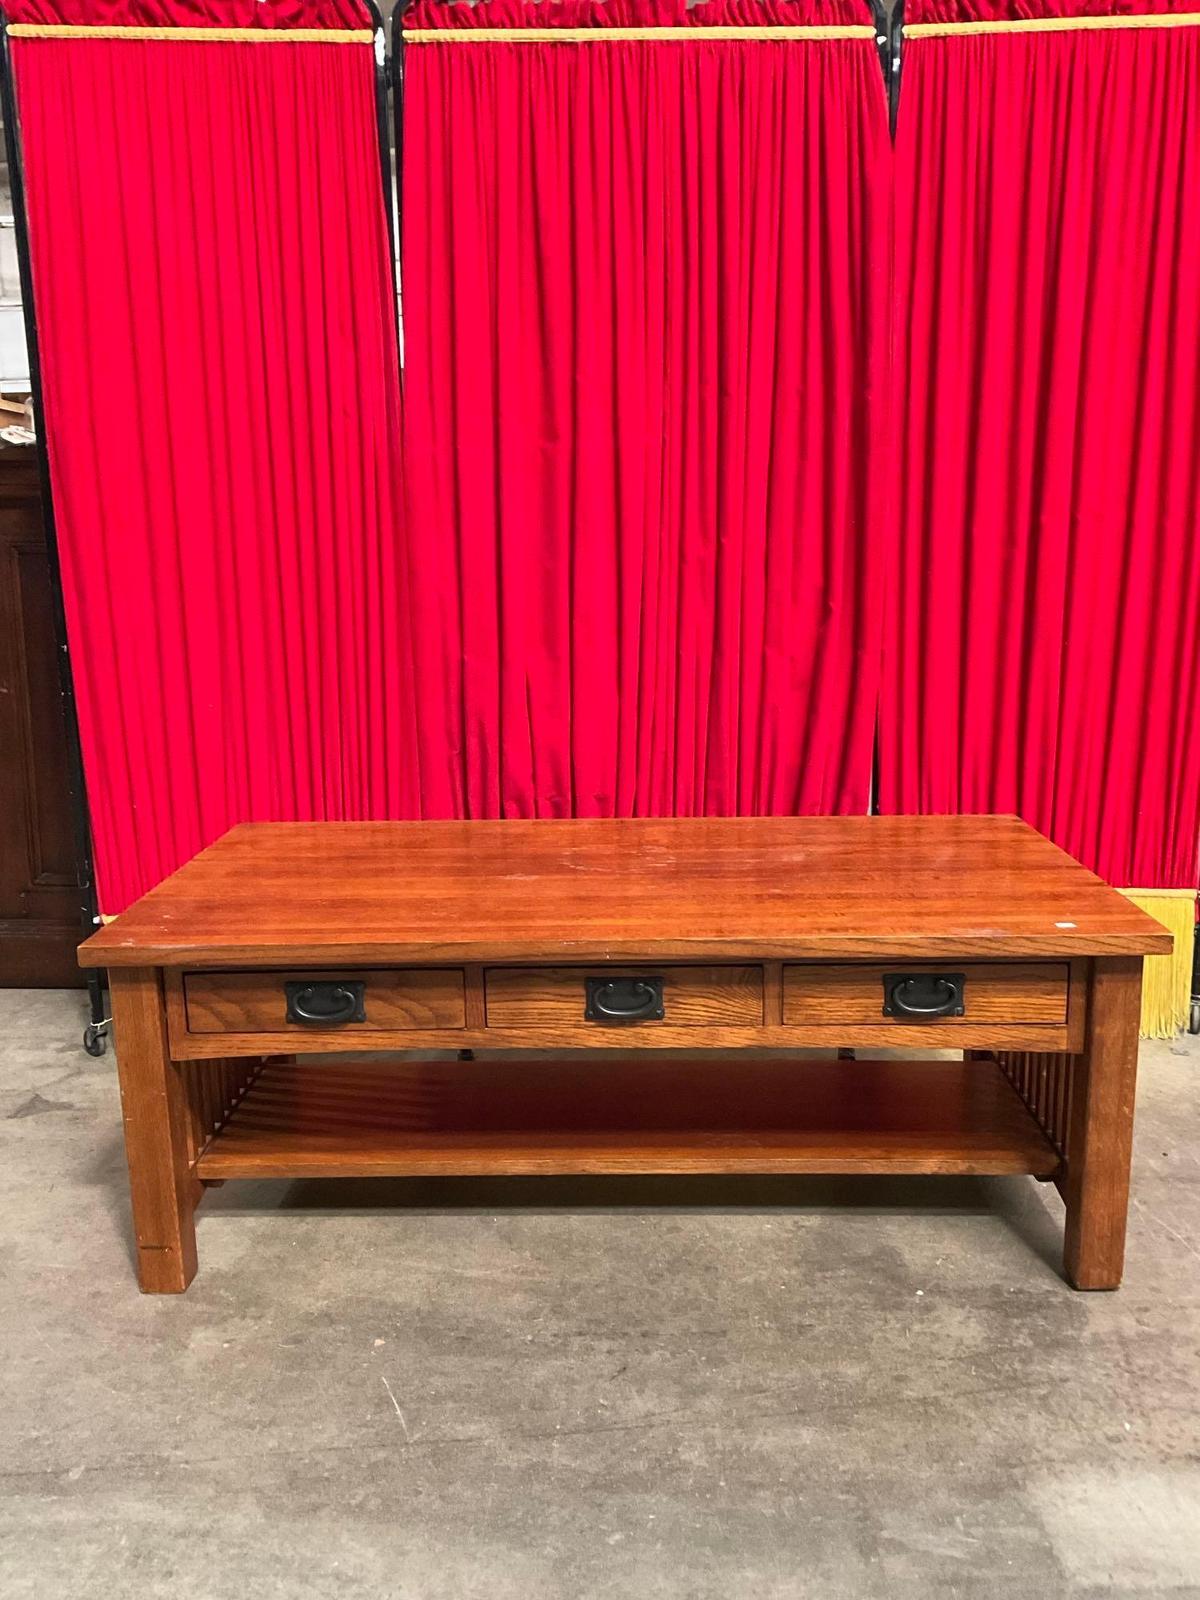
<box><xmin>182</xmin><ymin>966</ymin><xmax>467</xmax><ymax>1048</ymax></box>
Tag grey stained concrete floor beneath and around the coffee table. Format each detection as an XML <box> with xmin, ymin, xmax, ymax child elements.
<box><xmin>0</xmin><ymin>992</ymin><xmax>1200</xmax><ymax>1600</ymax></box>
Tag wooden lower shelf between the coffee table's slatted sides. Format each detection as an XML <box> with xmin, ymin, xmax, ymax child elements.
<box><xmin>190</xmin><ymin>1056</ymin><xmax>1059</xmax><ymax>1178</ymax></box>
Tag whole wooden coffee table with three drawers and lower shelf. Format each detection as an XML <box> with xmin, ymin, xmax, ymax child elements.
<box><xmin>80</xmin><ymin>818</ymin><xmax>1171</xmax><ymax>1293</ymax></box>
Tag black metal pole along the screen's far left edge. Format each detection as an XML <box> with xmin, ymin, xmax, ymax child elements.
<box><xmin>0</xmin><ymin>16</ymin><xmax>109</xmax><ymax>1054</ymax></box>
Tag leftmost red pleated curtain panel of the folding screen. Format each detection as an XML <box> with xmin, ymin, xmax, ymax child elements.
<box><xmin>10</xmin><ymin>0</ymin><xmax>414</xmax><ymax>912</ymax></box>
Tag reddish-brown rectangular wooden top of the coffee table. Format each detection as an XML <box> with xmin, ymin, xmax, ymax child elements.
<box><xmin>80</xmin><ymin>816</ymin><xmax>1171</xmax><ymax>968</ymax></box>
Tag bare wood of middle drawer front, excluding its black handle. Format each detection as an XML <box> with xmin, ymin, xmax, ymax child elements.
<box><xmin>483</xmin><ymin>965</ymin><xmax>763</xmax><ymax>1024</ymax></box>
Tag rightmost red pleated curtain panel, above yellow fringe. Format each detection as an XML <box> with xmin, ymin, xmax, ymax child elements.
<box><xmin>880</xmin><ymin>0</ymin><xmax>1200</xmax><ymax>888</ymax></box>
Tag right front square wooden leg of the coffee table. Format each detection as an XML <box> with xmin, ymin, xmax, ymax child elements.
<box><xmin>1064</xmin><ymin>955</ymin><xmax>1142</xmax><ymax>1290</ymax></box>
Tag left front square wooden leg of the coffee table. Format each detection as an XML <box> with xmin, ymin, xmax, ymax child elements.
<box><xmin>110</xmin><ymin>966</ymin><xmax>202</xmax><ymax>1294</ymax></box>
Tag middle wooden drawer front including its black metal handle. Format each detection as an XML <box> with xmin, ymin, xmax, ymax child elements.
<box><xmin>483</xmin><ymin>966</ymin><xmax>763</xmax><ymax>1030</ymax></box>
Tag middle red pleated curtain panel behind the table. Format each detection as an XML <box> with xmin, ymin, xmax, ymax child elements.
<box><xmin>403</xmin><ymin>0</ymin><xmax>890</xmax><ymax>816</ymax></box>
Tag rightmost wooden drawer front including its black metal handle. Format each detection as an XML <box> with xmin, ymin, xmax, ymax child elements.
<box><xmin>784</xmin><ymin>960</ymin><xmax>1069</xmax><ymax>1034</ymax></box>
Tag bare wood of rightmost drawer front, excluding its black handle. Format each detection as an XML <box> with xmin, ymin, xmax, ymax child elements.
<box><xmin>784</xmin><ymin>962</ymin><xmax>1067</xmax><ymax>1032</ymax></box>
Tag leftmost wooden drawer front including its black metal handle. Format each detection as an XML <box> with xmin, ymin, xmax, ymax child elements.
<box><xmin>184</xmin><ymin>968</ymin><xmax>467</xmax><ymax>1035</ymax></box>
